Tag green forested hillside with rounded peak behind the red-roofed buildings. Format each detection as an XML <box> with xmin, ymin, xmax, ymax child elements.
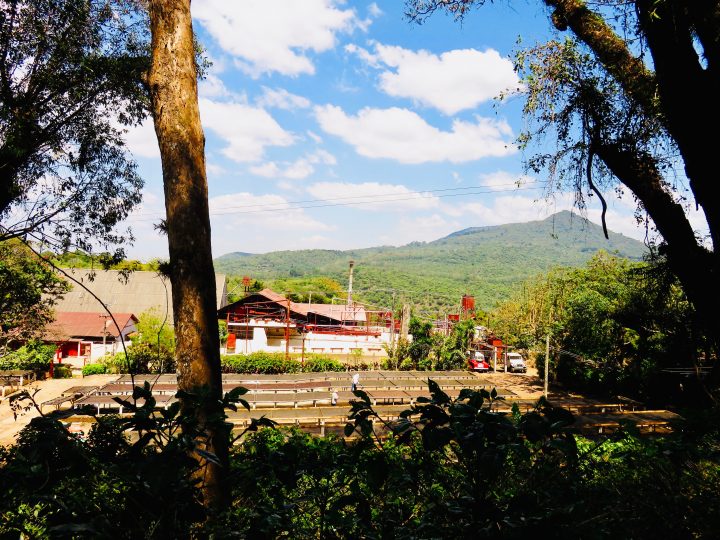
<box><xmin>215</xmin><ymin>212</ymin><xmax>645</xmax><ymax>314</ymax></box>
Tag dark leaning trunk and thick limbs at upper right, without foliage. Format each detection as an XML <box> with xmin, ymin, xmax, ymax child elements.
<box><xmin>544</xmin><ymin>0</ymin><xmax>720</xmax><ymax>388</ymax></box>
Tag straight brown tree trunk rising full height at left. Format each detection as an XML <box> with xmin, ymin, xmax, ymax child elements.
<box><xmin>148</xmin><ymin>0</ymin><xmax>229</xmax><ymax>508</ymax></box>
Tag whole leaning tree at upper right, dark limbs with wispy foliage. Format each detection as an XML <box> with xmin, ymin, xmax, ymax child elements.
<box><xmin>407</xmin><ymin>0</ymin><xmax>720</xmax><ymax>385</ymax></box>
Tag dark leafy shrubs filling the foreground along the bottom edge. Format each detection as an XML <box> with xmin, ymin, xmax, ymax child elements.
<box><xmin>0</xmin><ymin>382</ymin><xmax>720</xmax><ymax>540</ymax></box>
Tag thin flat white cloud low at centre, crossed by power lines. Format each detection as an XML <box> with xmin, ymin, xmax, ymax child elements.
<box><xmin>307</xmin><ymin>182</ymin><xmax>439</xmax><ymax>210</ymax></box>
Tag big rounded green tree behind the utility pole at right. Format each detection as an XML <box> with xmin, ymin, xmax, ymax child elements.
<box><xmin>492</xmin><ymin>252</ymin><xmax>707</xmax><ymax>398</ymax></box>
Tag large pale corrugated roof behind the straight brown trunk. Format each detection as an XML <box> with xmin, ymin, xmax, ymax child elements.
<box><xmin>50</xmin><ymin>268</ymin><xmax>227</xmax><ymax>324</ymax></box>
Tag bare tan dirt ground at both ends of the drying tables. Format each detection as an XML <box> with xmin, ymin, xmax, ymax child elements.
<box><xmin>0</xmin><ymin>368</ymin><xmax>543</xmax><ymax>445</ymax></box>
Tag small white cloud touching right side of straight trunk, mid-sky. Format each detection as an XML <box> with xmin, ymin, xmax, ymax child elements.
<box><xmin>200</xmin><ymin>99</ymin><xmax>295</xmax><ymax>162</ymax></box>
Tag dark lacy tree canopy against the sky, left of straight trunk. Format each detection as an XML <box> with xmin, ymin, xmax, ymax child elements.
<box><xmin>0</xmin><ymin>0</ymin><xmax>149</xmax><ymax>255</ymax></box>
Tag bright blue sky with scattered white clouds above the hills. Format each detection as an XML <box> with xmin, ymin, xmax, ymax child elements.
<box><xmin>118</xmin><ymin>0</ymin><xmax>704</xmax><ymax>260</ymax></box>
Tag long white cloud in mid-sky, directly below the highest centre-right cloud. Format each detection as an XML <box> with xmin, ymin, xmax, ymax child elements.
<box><xmin>315</xmin><ymin>105</ymin><xmax>517</xmax><ymax>163</ymax></box>
